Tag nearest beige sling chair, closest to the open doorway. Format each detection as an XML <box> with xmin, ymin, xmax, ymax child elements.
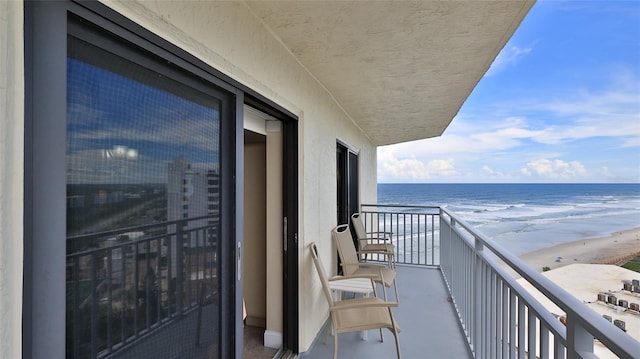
<box><xmin>309</xmin><ymin>243</ymin><xmax>400</xmax><ymax>359</ymax></box>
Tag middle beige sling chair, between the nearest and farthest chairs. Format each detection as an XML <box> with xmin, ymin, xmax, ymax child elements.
<box><xmin>331</xmin><ymin>224</ymin><xmax>399</xmax><ymax>302</ymax></box>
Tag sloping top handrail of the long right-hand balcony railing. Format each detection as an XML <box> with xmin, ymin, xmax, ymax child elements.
<box><xmin>440</xmin><ymin>208</ymin><xmax>640</xmax><ymax>353</ymax></box>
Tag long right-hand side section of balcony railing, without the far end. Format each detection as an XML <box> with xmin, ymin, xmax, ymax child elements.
<box><xmin>439</xmin><ymin>208</ymin><xmax>640</xmax><ymax>359</ymax></box>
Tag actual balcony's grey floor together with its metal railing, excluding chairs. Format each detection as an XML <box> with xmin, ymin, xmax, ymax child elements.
<box><xmin>301</xmin><ymin>205</ymin><xmax>640</xmax><ymax>358</ymax></box>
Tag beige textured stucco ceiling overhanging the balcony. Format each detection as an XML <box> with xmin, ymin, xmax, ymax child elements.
<box><xmin>247</xmin><ymin>0</ymin><xmax>534</xmax><ymax>145</ymax></box>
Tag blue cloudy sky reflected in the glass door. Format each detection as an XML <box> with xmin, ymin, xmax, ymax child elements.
<box><xmin>67</xmin><ymin>58</ymin><xmax>220</xmax><ymax>184</ymax></box>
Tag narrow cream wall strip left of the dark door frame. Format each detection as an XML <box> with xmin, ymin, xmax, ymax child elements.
<box><xmin>0</xmin><ymin>1</ymin><xmax>24</xmax><ymax>358</ymax></box>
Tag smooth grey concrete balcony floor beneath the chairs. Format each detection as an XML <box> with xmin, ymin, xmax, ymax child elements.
<box><xmin>298</xmin><ymin>265</ymin><xmax>472</xmax><ymax>359</ymax></box>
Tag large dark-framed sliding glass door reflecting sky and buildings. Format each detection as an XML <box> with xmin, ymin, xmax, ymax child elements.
<box><xmin>23</xmin><ymin>2</ymin><xmax>243</xmax><ymax>358</ymax></box>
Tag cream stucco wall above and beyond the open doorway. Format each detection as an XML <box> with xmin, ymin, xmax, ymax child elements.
<box><xmin>105</xmin><ymin>1</ymin><xmax>376</xmax><ymax>351</ymax></box>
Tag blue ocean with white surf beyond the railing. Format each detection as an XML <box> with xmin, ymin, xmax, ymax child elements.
<box><xmin>378</xmin><ymin>184</ymin><xmax>640</xmax><ymax>255</ymax></box>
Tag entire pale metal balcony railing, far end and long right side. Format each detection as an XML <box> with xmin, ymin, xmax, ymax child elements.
<box><xmin>361</xmin><ymin>204</ymin><xmax>640</xmax><ymax>359</ymax></box>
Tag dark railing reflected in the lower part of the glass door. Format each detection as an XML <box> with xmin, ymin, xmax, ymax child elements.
<box><xmin>66</xmin><ymin>216</ymin><xmax>218</xmax><ymax>358</ymax></box>
